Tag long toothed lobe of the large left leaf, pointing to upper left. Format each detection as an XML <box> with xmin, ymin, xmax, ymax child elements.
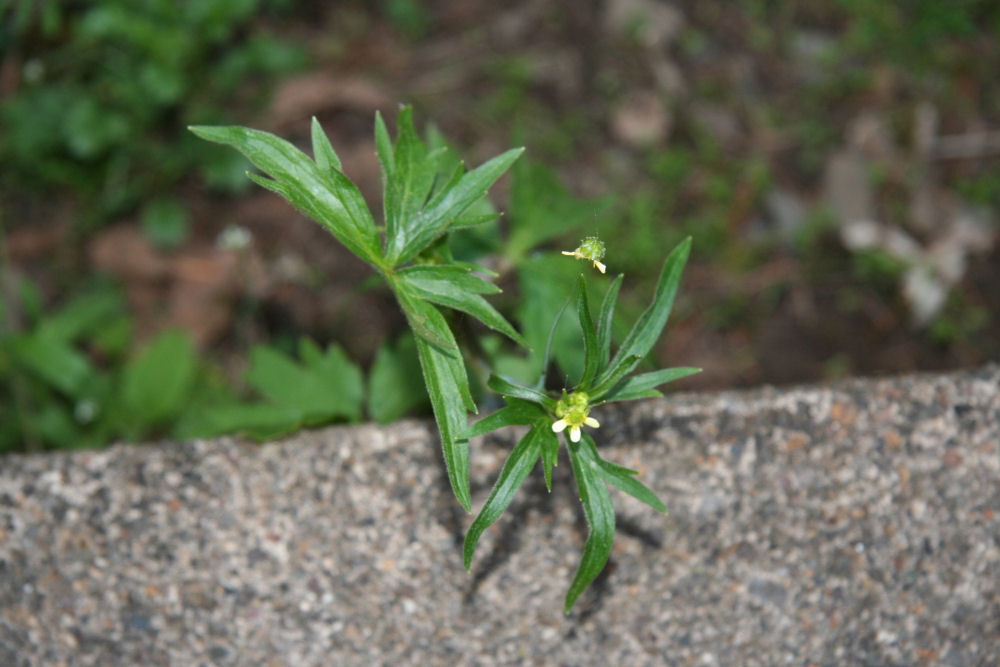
<box><xmin>188</xmin><ymin>125</ymin><xmax>384</xmax><ymax>267</ymax></box>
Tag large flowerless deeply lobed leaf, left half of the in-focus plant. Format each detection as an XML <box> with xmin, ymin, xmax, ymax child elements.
<box><xmin>190</xmin><ymin>108</ymin><xmax>524</xmax><ymax>509</ymax></box>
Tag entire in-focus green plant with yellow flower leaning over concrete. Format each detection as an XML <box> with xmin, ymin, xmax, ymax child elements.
<box><xmin>191</xmin><ymin>108</ymin><xmax>698</xmax><ymax>613</ymax></box>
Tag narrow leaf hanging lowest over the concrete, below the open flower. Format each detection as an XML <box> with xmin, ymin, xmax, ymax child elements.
<box><xmin>564</xmin><ymin>434</ymin><xmax>615</xmax><ymax>614</ymax></box>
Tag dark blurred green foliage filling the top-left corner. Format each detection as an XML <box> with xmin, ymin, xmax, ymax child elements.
<box><xmin>0</xmin><ymin>0</ymin><xmax>306</xmax><ymax>226</ymax></box>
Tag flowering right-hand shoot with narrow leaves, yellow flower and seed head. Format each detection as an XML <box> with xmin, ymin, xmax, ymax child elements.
<box><xmin>462</xmin><ymin>238</ymin><xmax>700</xmax><ymax>613</ymax></box>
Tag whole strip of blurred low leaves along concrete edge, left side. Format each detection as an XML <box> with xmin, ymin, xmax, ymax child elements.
<box><xmin>0</xmin><ymin>274</ymin><xmax>368</xmax><ymax>453</ymax></box>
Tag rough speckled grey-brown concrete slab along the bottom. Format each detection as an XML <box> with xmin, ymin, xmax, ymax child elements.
<box><xmin>0</xmin><ymin>366</ymin><xmax>1000</xmax><ymax>665</ymax></box>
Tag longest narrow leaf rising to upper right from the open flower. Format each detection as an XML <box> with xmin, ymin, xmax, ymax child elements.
<box><xmin>594</xmin><ymin>238</ymin><xmax>691</xmax><ymax>394</ymax></box>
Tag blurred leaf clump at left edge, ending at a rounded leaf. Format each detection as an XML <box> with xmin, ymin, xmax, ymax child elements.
<box><xmin>0</xmin><ymin>282</ymin><xmax>209</xmax><ymax>452</ymax></box>
